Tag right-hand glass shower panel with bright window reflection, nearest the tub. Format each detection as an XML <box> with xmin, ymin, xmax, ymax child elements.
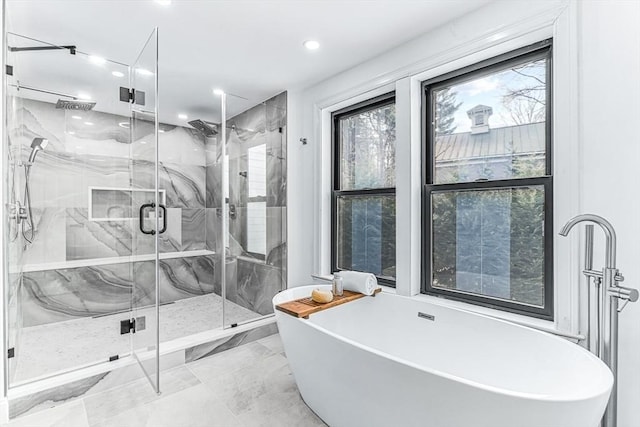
<box><xmin>221</xmin><ymin>93</ymin><xmax>287</xmax><ymax>327</ymax></box>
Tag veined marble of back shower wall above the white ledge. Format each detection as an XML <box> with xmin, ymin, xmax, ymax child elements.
<box><xmin>10</xmin><ymin>99</ymin><xmax>206</xmax><ymax>265</ymax></box>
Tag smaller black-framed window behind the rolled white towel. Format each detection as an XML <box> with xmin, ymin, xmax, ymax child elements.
<box><xmin>331</xmin><ymin>94</ymin><xmax>396</xmax><ymax>286</ymax></box>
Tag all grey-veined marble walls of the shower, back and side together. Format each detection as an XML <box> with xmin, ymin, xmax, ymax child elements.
<box><xmin>8</xmin><ymin>92</ymin><xmax>287</xmax><ymax>384</ymax></box>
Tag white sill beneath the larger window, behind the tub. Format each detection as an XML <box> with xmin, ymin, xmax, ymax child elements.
<box><xmin>412</xmin><ymin>288</ymin><xmax>585</xmax><ymax>343</ymax></box>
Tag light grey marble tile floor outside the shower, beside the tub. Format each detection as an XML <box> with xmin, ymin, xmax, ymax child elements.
<box><xmin>1</xmin><ymin>334</ymin><xmax>326</xmax><ymax>427</ymax></box>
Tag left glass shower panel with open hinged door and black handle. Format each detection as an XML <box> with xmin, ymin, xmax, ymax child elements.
<box><xmin>3</xmin><ymin>29</ymin><xmax>161</xmax><ymax>391</ymax></box>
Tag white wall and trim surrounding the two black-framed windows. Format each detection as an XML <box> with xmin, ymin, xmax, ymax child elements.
<box><xmin>288</xmin><ymin>0</ymin><xmax>640</xmax><ymax>427</ymax></box>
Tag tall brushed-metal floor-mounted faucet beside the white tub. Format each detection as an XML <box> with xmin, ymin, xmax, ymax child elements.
<box><xmin>560</xmin><ymin>214</ymin><xmax>638</xmax><ymax>427</ymax></box>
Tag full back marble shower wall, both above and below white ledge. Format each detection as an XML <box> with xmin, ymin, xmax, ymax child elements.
<box><xmin>9</xmin><ymin>98</ymin><xmax>212</xmax><ymax>330</ymax></box>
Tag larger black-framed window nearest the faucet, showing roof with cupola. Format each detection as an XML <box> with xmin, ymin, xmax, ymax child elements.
<box><xmin>422</xmin><ymin>40</ymin><xmax>553</xmax><ymax>319</ymax></box>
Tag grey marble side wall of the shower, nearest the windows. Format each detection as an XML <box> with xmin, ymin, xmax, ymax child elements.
<box><xmin>206</xmin><ymin>92</ymin><xmax>287</xmax><ymax>315</ymax></box>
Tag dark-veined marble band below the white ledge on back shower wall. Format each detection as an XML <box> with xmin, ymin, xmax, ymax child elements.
<box><xmin>21</xmin><ymin>255</ymin><xmax>214</xmax><ymax>327</ymax></box>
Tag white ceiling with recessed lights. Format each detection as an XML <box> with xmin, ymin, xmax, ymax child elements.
<box><xmin>7</xmin><ymin>0</ymin><xmax>489</xmax><ymax>125</ymax></box>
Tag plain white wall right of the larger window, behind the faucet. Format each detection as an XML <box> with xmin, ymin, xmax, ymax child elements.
<box><xmin>578</xmin><ymin>1</ymin><xmax>640</xmax><ymax>427</ymax></box>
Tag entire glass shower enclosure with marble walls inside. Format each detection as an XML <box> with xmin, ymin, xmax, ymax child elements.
<box><xmin>2</xmin><ymin>17</ymin><xmax>287</xmax><ymax>394</ymax></box>
